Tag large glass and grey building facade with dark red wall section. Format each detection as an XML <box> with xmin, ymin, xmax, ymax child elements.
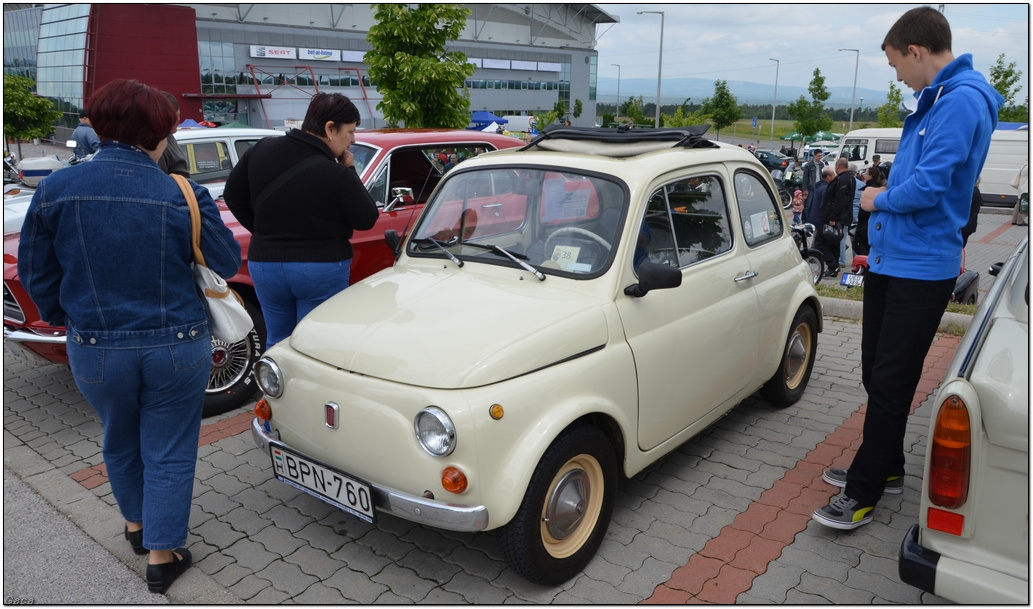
<box><xmin>4</xmin><ymin>3</ymin><xmax>619</xmax><ymax>136</ymax></box>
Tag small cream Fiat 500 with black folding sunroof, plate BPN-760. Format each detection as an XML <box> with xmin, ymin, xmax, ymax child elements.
<box><xmin>252</xmin><ymin>128</ymin><xmax>821</xmax><ymax>584</ymax></box>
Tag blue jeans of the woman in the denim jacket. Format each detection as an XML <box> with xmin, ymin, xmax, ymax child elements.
<box><xmin>67</xmin><ymin>332</ymin><xmax>212</xmax><ymax>550</ymax></box>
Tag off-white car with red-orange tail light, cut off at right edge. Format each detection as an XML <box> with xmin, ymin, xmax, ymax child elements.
<box><xmin>900</xmin><ymin>237</ymin><xmax>1030</xmax><ymax>605</ymax></box>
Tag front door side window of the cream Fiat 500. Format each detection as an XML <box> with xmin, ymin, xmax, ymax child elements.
<box><xmin>634</xmin><ymin>175</ymin><xmax>731</xmax><ymax>267</ymax></box>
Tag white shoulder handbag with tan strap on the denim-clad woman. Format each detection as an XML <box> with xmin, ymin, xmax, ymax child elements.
<box><xmin>173</xmin><ymin>174</ymin><xmax>254</xmax><ymax>344</ymax></box>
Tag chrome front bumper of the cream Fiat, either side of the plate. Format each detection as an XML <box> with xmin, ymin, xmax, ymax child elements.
<box><xmin>251</xmin><ymin>418</ymin><xmax>488</xmax><ymax>533</ymax></box>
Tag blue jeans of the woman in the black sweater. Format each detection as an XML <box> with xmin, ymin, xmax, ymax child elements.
<box><xmin>248</xmin><ymin>258</ymin><xmax>351</xmax><ymax>348</ymax></box>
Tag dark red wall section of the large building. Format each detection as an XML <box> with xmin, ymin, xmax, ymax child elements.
<box><xmin>84</xmin><ymin>4</ymin><xmax>204</xmax><ymax>122</ymax></box>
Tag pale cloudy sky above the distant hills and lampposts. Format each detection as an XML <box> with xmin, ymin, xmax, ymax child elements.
<box><xmin>596</xmin><ymin>1</ymin><xmax>1030</xmax><ymax>101</ymax></box>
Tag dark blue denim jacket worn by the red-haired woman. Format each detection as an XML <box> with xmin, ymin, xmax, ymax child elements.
<box><xmin>18</xmin><ymin>140</ymin><xmax>241</xmax><ymax>348</ymax></box>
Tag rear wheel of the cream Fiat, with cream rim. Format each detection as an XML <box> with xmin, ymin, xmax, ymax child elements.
<box><xmin>760</xmin><ymin>306</ymin><xmax>818</xmax><ymax>408</ymax></box>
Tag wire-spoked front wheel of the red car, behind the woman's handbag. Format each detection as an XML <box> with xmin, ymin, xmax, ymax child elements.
<box><xmin>201</xmin><ymin>300</ymin><xmax>265</xmax><ymax>417</ymax></box>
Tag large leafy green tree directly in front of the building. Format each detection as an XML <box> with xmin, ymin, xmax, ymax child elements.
<box><xmin>363</xmin><ymin>4</ymin><xmax>474</xmax><ymax>129</ymax></box>
